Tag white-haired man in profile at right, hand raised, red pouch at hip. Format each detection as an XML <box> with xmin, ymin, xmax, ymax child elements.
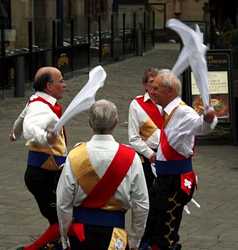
<box><xmin>145</xmin><ymin>70</ymin><xmax>217</xmax><ymax>250</ymax></box>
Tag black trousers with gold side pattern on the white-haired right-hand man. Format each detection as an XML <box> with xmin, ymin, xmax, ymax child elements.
<box><xmin>143</xmin><ymin>175</ymin><xmax>194</xmax><ymax>250</ymax></box>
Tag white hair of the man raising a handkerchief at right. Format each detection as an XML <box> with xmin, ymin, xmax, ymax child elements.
<box><xmin>158</xmin><ymin>69</ymin><xmax>182</xmax><ymax>96</ymax></box>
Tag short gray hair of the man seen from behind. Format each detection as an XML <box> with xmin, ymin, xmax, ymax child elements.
<box><xmin>89</xmin><ymin>99</ymin><xmax>118</xmax><ymax>134</ymax></box>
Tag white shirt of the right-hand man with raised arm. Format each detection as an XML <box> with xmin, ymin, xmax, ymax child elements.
<box><xmin>156</xmin><ymin>97</ymin><xmax>217</xmax><ymax>161</ymax></box>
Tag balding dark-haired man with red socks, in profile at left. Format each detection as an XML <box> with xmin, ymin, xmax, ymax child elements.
<box><xmin>10</xmin><ymin>67</ymin><xmax>67</xmax><ymax>250</ymax></box>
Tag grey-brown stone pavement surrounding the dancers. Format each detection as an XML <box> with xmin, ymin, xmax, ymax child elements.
<box><xmin>0</xmin><ymin>45</ymin><xmax>238</xmax><ymax>250</ymax></box>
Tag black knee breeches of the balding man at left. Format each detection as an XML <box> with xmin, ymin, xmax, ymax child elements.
<box><xmin>25</xmin><ymin>166</ymin><xmax>61</xmax><ymax>224</ymax></box>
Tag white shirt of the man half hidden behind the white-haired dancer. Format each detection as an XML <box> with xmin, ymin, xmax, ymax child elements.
<box><xmin>128</xmin><ymin>92</ymin><xmax>161</xmax><ymax>159</ymax></box>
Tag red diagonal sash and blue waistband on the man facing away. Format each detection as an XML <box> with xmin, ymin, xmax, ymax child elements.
<box><xmin>73</xmin><ymin>144</ymin><xmax>135</xmax><ymax>239</ymax></box>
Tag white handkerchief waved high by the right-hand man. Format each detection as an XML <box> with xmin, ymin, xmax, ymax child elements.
<box><xmin>166</xmin><ymin>19</ymin><xmax>209</xmax><ymax>108</ymax></box>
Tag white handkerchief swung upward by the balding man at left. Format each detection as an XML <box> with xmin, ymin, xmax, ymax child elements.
<box><xmin>52</xmin><ymin>66</ymin><xmax>107</xmax><ymax>133</ymax></box>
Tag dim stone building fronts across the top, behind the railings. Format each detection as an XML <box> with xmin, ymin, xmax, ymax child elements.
<box><xmin>0</xmin><ymin>0</ymin><xmax>238</xmax><ymax>48</ymax></box>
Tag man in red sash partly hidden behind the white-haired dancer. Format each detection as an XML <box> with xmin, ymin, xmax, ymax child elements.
<box><xmin>128</xmin><ymin>68</ymin><xmax>162</xmax><ymax>190</ymax></box>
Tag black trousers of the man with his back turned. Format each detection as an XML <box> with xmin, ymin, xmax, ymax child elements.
<box><xmin>70</xmin><ymin>225</ymin><xmax>129</xmax><ymax>250</ymax></box>
